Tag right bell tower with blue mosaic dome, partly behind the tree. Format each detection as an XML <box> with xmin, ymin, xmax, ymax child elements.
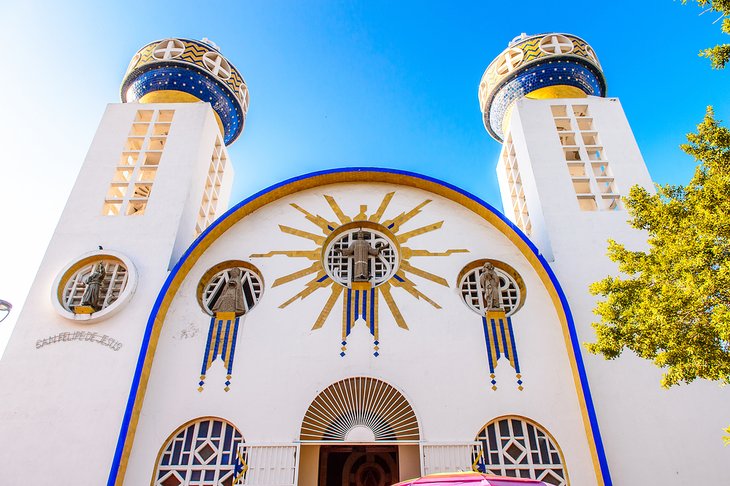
<box><xmin>479</xmin><ymin>33</ymin><xmax>727</xmax><ymax>484</ymax></box>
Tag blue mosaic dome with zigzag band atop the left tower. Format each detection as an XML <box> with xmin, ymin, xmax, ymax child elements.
<box><xmin>121</xmin><ymin>38</ymin><xmax>249</xmax><ymax>145</ymax></box>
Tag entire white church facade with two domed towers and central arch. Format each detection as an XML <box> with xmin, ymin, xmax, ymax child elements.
<box><xmin>0</xmin><ymin>34</ymin><xmax>730</xmax><ymax>486</ymax></box>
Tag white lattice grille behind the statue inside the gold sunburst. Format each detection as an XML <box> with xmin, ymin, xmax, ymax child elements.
<box><xmin>325</xmin><ymin>229</ymin><xmax>399</xmax><ymax>287</ymax></box>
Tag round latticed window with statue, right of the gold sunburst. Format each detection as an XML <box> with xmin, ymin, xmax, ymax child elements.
<box><xmin>459</xmin><ymin>260</ymin><xmax>525</xmax><ymax>316</ymax></box>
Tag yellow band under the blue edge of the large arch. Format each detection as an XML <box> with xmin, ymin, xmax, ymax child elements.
<box><xmin>115</xmin><ymin>170</ymin><xmax>605</xmax><ymax>486</ymax></box>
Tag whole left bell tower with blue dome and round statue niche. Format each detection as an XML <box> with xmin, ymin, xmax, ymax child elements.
<box><xmin>0</xmin><ymin>38</ymin><xmax>249</xmax><ymax>484</ymax></box>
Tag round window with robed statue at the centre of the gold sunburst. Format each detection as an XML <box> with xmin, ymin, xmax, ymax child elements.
<box><xmin>323</xmin><ymin>222</ymin><xmax>398</xmax><ymax>287</ymax></box>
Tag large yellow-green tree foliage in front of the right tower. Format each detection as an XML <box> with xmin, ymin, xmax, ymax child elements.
<box><xmin>587</xmin><ymin>108</ymin><xmax>730</xmax><ymax>387</ymax></box>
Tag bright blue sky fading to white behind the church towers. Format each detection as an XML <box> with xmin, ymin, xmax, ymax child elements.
<box><xmin>0</xmin><ymin>0</ymin><xmax>730</xmax><ymax>350</ymax></box>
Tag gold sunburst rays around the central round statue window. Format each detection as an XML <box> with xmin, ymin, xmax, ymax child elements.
<box><xmin>251</xmin><ymin>192</ymin><xmax>469</xmax><ymax>348</ymax></box>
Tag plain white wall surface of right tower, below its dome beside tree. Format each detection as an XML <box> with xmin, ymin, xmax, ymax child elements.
<box><xmin>504</xmin><ymin>97</ymin><xmax>730</xmax><ymax>486</ymax></box>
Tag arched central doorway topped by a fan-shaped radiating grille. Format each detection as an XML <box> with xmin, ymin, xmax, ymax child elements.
<box><xmin>300</xmin><ymin>377</ymin><xmax>420</xmax><ymax>486</ymax></box>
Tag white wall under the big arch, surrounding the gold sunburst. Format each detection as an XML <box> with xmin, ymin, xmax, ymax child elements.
<box><xmin>125</xmin><ymin>182</ymin><xmax>595</xmax><ymax>485</ymax></box>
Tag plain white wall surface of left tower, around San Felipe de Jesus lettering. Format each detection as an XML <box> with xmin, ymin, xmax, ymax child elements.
<box><xmin>0</xmin><ymin>103</ymin><xmax>229</xmax><ymax>485</ymax></box>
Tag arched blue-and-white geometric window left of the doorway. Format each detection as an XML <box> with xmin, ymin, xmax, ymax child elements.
<box><xmin>152</xmin><ymin>418</ymin><xmax>244</xmax><ymax>486</ymax></box>
